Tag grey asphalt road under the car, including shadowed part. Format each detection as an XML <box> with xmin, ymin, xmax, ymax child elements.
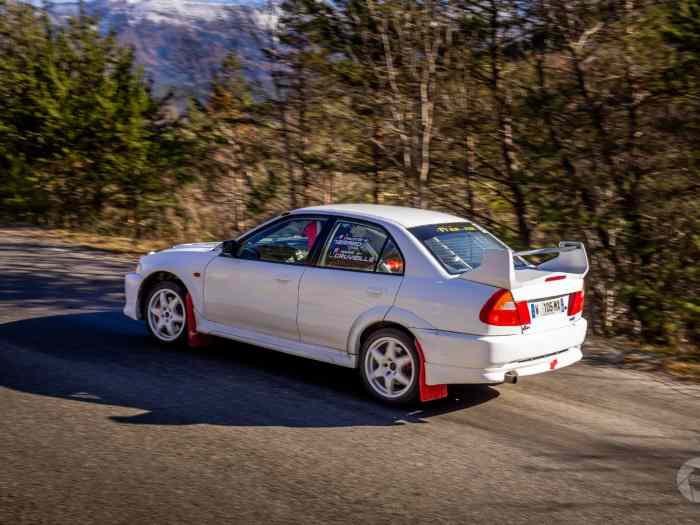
<box><xmin>0</xmin><ymin>226</ymin><xmax>700</xmax><ymax>525</ymax></box>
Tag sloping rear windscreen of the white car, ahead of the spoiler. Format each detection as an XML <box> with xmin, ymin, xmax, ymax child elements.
<box><xmin>409</xmin><ymin>222</ymin><xmax>506</xmax><ymax>273</ymax></box>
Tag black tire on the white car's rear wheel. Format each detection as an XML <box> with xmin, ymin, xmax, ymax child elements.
<box><xmin>360</xmin><ymin>328</ymin><xmax>420</xmax><ymax>405</ymax></box>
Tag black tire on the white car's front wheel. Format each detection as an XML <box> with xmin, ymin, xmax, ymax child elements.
<box><xmin>143</xmin><ymin>281</ymin><xmax>187</xmax><ymax>346</ymax></box>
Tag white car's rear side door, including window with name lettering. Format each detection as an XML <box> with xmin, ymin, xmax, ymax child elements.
<box><xmin>298</xmin><ymin>219</ymin><xmax>404</xmax><ymax>351</ymax></box>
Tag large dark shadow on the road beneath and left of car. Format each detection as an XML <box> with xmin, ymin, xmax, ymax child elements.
<box><xmin>0</xmin><ymin>311</ymin><xmax>498</xmax><ymax>427</ymax></box>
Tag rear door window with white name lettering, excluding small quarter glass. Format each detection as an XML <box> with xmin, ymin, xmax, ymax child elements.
<box><xmin>319</xmin><ymin>221</ymin><xmax>387</xmax><ymax>272</ymax></box>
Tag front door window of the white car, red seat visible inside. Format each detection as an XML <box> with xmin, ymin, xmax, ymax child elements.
<box><xmin>236</xmin><ymin>219</ymin><xmax>325</xmax><ymax>264</ymax></box>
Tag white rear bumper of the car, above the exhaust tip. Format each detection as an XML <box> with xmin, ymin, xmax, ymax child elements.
<box><xmin>415</xmin><ymin>318</ymin><xmax>587</xmax><ymax>385</ymax></box>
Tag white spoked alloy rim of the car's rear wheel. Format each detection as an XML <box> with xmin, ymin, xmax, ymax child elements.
<box><xmin>363</xmin><ymin>336</ymin><xmax>418</xmax><ymax>400</ymax></box>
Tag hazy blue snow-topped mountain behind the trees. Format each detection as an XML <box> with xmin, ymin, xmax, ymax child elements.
<box><xmin>42</xmin><ymin>0</ymin><xmax>276</xmax><ymax>98</ymax></box>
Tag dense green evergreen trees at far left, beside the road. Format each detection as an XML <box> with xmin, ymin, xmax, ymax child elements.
<box><xmin>0</xmin><ymin>1</ymin><xmax>191</xmax><ymax>231</ymax></box>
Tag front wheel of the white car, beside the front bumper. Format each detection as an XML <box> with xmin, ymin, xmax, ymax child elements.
<box><xmin>145</xmin><ymin>281</ymin><xmax>187</xmax><ymax>345</ymax></box>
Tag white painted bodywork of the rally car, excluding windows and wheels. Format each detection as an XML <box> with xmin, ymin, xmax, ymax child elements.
<box><xmin>124</xmin><ymin>205</ymin><xmax>588</xmax><ymax>385</ymax></box>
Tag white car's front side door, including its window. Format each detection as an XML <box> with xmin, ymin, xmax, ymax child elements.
<box><xmin>204</xmin><ymin>218</ymin><xmax>325</xmax><ymax>341</ymax></box>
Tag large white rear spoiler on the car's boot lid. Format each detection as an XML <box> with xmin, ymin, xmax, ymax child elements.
<box><xmin>460</xmin><ymin>241</ymin><xmax>589</xmax><ymax>290</ymax></box>
